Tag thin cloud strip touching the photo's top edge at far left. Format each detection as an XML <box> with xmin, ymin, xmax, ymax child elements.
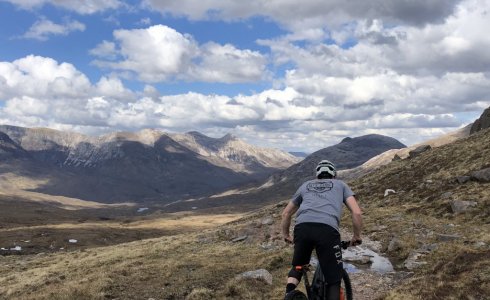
<box><xmin>1</xmin><ymin>0</ymin><xmax>123</xmax><ymax>14</ymax></box>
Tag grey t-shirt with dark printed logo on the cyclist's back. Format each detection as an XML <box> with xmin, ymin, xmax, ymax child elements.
<box><xmin>291</xmin><ymin>179</ymin><xmax>355</xmax><ymax>230</ymax></box>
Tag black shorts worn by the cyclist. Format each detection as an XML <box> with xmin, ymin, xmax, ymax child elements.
<box><xmin>292</xmin><ymin>223</ymin><xmax>343</xmax><ymax>284</ymax></box>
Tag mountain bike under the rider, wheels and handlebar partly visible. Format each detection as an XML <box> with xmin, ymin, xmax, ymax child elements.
<box><xmin>285</xmin><ymin>241</ymin><xmax>362</xmax><ymax>300</ymax></box>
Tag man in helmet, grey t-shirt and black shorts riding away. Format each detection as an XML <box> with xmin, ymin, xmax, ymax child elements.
<box><xmin>281</xmin><ymin>160</ymin><xmax>362</xmax><ymax>300</ymax></box>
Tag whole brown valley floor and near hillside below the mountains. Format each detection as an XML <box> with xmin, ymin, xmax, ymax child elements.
<box><xmin>0</xmin><ymin>113</ymin><xmax>490</xmax><ymax>300</ymax></box>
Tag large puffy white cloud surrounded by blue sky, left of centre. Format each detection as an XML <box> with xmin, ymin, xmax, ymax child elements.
<box><xmin>91</xmin><ymin>25</ymin><xmax>267</xmax><ymax>83</ymax></box>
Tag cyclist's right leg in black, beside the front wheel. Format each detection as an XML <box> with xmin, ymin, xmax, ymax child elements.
<box><xmin>316</xmin><ymin>225</ymin><xmax>343</xmax><ymax>300</ymax></box>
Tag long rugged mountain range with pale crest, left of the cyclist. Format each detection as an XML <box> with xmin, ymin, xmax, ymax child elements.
<box><xmin>0</xmin><ymin>125</ymin><xmax>298</xmax><ymax>202</ymax></box>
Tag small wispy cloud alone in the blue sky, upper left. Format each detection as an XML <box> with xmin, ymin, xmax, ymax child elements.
<box><xmin>22</xmin><ymin>18</ymin><xmax>85</xmax><ymax>41</ymax></box>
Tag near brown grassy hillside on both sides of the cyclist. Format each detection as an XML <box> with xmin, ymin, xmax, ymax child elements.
<box><xmin>0</xmin><ymin>130</ymin><xmax>490</xmax><ymax>299</ymax></box>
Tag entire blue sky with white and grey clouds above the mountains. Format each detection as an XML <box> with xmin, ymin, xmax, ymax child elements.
<box><xmin>0</xmin><ymin>0</ymin><xmax>490</xmax><ymax>153</ymax></box>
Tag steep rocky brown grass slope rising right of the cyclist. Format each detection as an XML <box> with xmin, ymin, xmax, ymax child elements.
<box><xmin>352</xmin><ymin>130</ymin><xmax>490</xmax><ymax>299</ymax></box>
